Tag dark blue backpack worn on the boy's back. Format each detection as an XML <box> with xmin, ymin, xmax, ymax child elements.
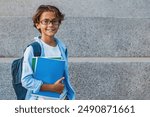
<box><xmin>11</xmin><ymin>42</ymin><xmax>41</xmax><ymax>100</ymax></box>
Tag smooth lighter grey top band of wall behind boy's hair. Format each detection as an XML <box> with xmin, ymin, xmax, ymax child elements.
<box><xmin>0</xmin><ymin>0</ymin><xmax>150</xmax><ymax>18</ymax></box>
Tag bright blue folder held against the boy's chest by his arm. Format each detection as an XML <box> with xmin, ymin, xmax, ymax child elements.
<box><xmin>33</xmin><ymin>57</ymin><xmax>65</xmax><ymax>99</ymax></box>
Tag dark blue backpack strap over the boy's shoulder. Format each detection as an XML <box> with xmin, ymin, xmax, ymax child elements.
<box><xmin>30</xmin><ymin>42</ymin><xmax>41</xmax><ymax>57</ymax></box>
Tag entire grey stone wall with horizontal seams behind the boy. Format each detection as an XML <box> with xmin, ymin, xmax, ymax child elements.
<box><xmin>0</xmin><ymin>0</ymin><xmax>150</xmax><ymax>100</ymax></box>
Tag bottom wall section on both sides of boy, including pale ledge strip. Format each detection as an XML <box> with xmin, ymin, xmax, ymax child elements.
<box><xmin>0</xmin><ymin>58</ymin><xmax>150</xmax><ymax>100</ymax></box>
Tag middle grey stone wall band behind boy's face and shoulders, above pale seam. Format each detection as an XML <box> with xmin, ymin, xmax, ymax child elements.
<box><xmin>0</xmin><ymin>17</ymin><xmax>150</xmax><ymax>57</ymax></box>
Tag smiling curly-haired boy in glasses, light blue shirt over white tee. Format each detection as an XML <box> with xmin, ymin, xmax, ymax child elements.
<box><xmin>21</xmin><ymin>5</ymin><xmax>75</xmax><ymax>100</ymax></box>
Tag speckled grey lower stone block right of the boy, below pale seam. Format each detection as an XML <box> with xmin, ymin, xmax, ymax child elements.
<box><xmin>70</xmin><ymin>62</ymin><xmax>150</xmax><ymax>100</ymax></box>
